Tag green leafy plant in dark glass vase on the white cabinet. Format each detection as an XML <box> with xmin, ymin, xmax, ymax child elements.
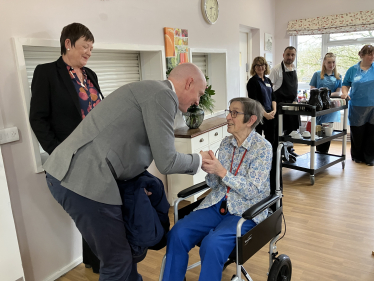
<box><xmin>166</xmin><ymin>68</ymin><xmax>216</xmax><ymax>129</ymax></box>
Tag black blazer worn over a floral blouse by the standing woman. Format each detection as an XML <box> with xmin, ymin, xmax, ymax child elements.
<box><xmin>30</xmin><ymin>57</ymin><xmax>103</xmax><ymax>154</ymax></box>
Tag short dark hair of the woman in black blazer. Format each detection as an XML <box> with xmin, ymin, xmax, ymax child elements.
<box><xmin>60</xmin><ymin>22</ymin><xmax>95</xmax><ymax>55</ymax></box>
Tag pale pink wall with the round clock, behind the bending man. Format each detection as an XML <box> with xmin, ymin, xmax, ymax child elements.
<box><xmin>0</xmin><ymin>0</ymin><xmax>275</xmax><ymax>281</ymax></box>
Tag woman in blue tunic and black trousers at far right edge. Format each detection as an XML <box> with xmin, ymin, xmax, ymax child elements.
<box><xmin>341</xmin><ymin>45</ymin><xmax>374</xmax><ymax>166</ymax></box>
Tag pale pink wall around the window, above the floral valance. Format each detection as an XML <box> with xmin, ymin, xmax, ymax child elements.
<box><xmin>274</xmin><ymin>0</ymin><xmax>374</xmax><ymax>64</ymax></box>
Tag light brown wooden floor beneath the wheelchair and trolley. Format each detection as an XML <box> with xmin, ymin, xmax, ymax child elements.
<box><xmin>57</xmin><ymin>141</ymin><xmax>374</xmax><ymax>281</ymax></box>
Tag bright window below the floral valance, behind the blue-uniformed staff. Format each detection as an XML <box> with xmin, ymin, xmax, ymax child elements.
<box><xmin>296</xmin><ymin>31</ymin><xmax>374</xmax><ymax>90</ymax></box>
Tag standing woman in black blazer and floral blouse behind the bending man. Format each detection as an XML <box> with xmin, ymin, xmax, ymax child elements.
<box><xmin>30</xmin><ymin>23</ymin><xmax>103</xmax><ymax>273</ymax></box>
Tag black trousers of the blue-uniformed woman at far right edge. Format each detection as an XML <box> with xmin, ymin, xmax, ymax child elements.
<box><xmin>350</xmin><ymin>123</ymin><xmax>374</xmax><ymax>164</ymax></box>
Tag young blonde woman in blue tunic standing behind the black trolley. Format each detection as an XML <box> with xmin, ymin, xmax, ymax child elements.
<box><xmin>309</xmin><ymin>53</ymin><xmax>342</xmax><ymax>153</ymax></box>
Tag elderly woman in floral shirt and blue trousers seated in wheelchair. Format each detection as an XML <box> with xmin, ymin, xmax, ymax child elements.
<box><xmin>162</xmin><ymin>98</ymin><xmax>273</xmax><ymax>281</ymax></box>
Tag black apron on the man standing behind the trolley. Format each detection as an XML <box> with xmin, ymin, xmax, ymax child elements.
<box><xmin>274</xmin><ymin>63</ymin><xmax>301</xmax><ymax>135</ymax></box>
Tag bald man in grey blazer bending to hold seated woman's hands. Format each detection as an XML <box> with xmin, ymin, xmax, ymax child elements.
<box><xmin>43</xmin><ymin>63</ymin><xmax>210</xmax><ymax>281</ymax></box>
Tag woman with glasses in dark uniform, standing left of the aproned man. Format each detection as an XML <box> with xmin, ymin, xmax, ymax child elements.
<box><xmin>247</xmin><ymin>57</ymin><xmax>277</xmax><ymax>146</ymax></box>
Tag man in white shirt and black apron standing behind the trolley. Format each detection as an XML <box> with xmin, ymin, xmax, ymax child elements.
<box><xmin>269</xmin><ymin>46</ymin><xmax>300</xmax><ymax>135</ymax></box>
